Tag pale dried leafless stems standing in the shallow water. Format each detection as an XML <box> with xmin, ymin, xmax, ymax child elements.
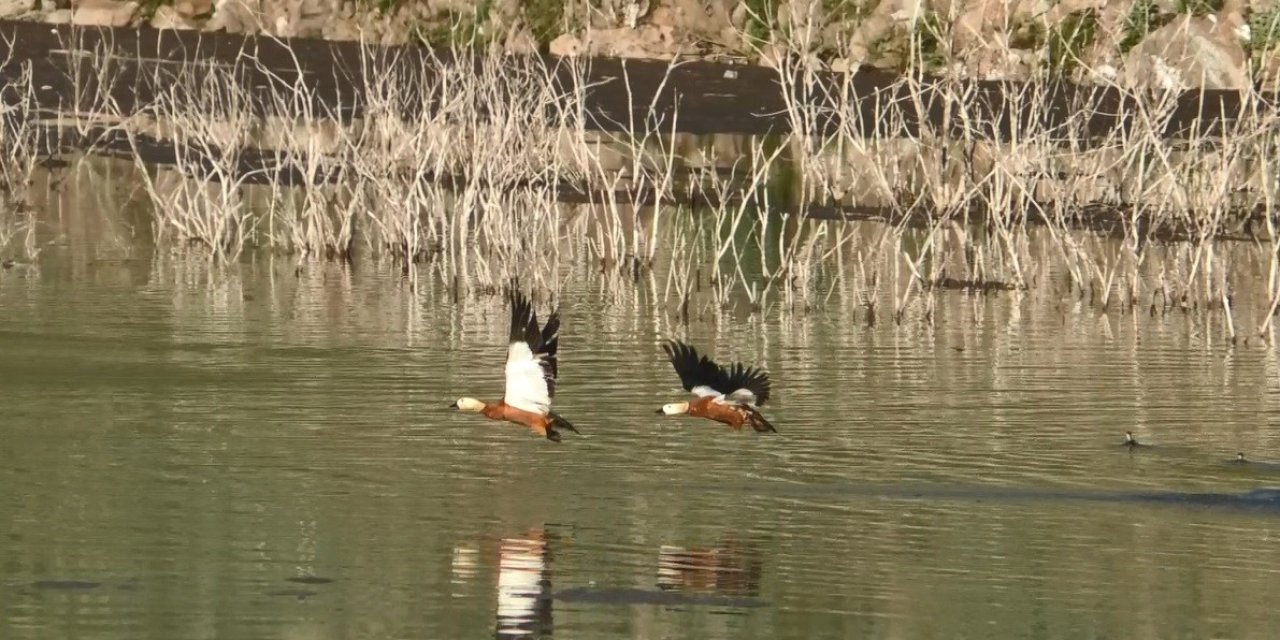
<box><xmin>0</xmin><ymin>8</ymin><xmax>1280</xmax><ymax>340</ymax></box>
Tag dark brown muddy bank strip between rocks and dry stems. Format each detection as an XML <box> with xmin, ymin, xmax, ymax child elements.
<box><xmin>0</xmin><ymin>20</ymin><xmax>1280</xmax><ymax>141</ymax></box>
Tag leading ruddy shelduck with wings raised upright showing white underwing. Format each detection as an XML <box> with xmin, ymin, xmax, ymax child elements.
<box><xmin>449</xmin><ymin>292</ymin><xmax>579</xmax><ymax>442</ymax></box>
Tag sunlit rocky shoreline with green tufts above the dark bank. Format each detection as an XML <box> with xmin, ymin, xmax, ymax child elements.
<box><xmin>0</xmin><ymin>0</ymin><xmax>1280</xmax><ymax>91</ymax></box>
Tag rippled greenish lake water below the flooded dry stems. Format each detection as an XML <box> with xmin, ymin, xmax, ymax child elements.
<box><xmin>0</xmin><ymin>212</ymin><xmax>1280</xmax><ymax>640</ymax></box>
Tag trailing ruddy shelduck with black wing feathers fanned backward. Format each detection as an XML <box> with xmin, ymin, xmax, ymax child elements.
<box><xmin>658</xmin><ymin>340</ymin><xmax>777</xmax><ymax>433</ymax></box>
